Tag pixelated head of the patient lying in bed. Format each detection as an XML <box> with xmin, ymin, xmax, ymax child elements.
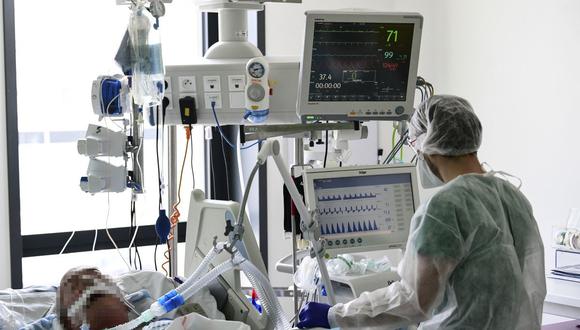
<box><xmin>57</xmin><ymin>267</ymin><xmax>129</xmax><ymax>330</ymax></box>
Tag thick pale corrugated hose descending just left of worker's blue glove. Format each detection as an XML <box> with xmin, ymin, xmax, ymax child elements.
<box><xmin>237</xmin><ymin>252</ymin><xmax>290</xmax><ymax>330</ymax></box>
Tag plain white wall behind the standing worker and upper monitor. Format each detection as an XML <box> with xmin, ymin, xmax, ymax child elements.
<box><xmin>266</xmin><ymin>0</ymin><xmax>580</xmax><ymax>284</ymax></box>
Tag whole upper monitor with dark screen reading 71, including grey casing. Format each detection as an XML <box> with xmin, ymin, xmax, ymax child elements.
<box><xmin>298</xmin><ymin>11</ymin><xmax>423</xmax><ymax>122</ymax></box>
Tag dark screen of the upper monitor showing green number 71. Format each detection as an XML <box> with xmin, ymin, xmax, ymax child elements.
<box><xmin>308</xmin><ymin>21</ymin><xmax>415</xmax><ymax>102</ymax></box>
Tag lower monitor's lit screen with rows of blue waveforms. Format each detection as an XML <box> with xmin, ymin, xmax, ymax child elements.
<box><xmin>313</xmin><ymin>173</ymin><xmax>415</xmax><ymax>238</ymax></box>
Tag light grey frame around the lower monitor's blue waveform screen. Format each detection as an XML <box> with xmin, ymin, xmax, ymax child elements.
<box><xmin>304</xmin><ymin>164</ymin><xmax>420</xmax><ymax>255</ymax></box>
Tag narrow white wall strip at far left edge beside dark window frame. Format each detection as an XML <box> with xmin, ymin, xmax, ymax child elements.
<box><xmin>0</xmin><ymin>7</ymin><xmax>10</xmax><ymax>289</ymax></box>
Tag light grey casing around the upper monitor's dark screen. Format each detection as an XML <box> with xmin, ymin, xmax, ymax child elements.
<box><xmin>297</xmin><ymin>11</ymin><xmax>423</xmax><ymax>122</ymax></box>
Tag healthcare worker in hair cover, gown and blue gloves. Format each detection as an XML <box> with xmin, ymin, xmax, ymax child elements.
<box><xmin>298</xmin><ymin>95</ymin><xmax>546</xmax><ymax>330</ymax></box>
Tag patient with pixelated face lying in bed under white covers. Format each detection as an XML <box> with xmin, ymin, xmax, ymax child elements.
<box><xmin>53</xmin><ymin>267</ymin><xmax>225</xmax><ymax>330</ymax></box>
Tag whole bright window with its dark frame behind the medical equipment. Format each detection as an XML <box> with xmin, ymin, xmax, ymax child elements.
<box><xmin>4</xmin><ymin>0</ymin><xmax>267</xmax><ymax>288</ymax></box>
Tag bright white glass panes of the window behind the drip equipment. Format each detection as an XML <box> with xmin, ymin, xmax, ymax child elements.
<box><xmin>10</xmin><ymin>0</ymin><xmax>205</xmax><ymax>286</ymax></box>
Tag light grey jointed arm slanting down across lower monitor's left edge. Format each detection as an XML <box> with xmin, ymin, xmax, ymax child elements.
<box><xmin>258</xmin><ymin>140</ymin><xmax>336</xmax><ymax>305</ymax></box>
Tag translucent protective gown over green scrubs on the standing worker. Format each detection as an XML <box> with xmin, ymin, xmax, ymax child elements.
<box><xmin>328</xmin><ymin>173</ymin><xmax>546</xmax><ymax>330</ymax></box>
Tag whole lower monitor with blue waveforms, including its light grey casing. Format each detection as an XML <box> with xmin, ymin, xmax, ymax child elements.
<box><xmin>304</xmin><ymin>166</ymin><xmax>419</xmax><ymax>253</ymax></box>
